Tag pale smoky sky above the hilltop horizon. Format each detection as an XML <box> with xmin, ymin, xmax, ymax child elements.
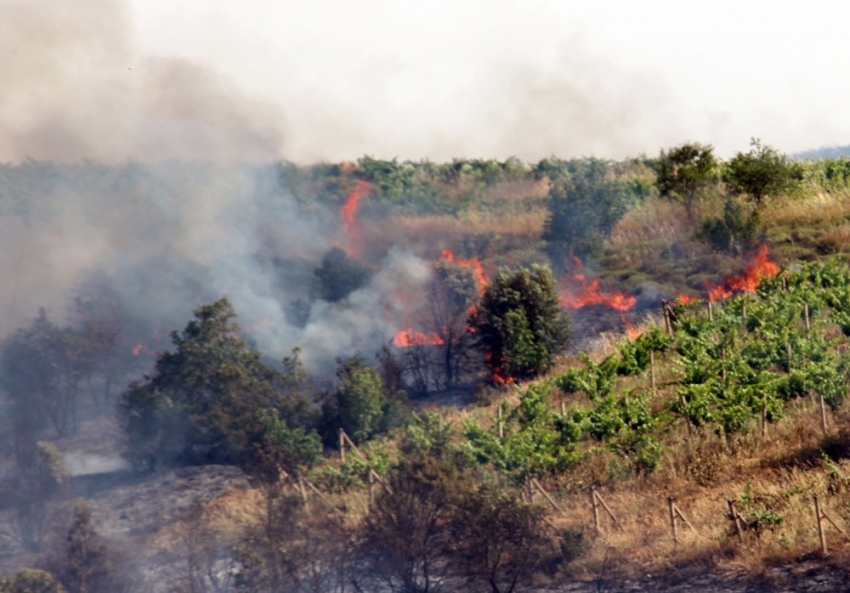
<box><xmin>0</xmin><ymin>0</ymin><xmax>850</xmax><ymax>162</ymax></box>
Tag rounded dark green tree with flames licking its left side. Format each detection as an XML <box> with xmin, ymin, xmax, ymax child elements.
<box><xmin>471</xmin><ymin>266</ymin><xmax>570</xmax><ymax>379</ymax></box>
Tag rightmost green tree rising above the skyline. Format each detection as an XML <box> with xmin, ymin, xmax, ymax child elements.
<box><xmin>723</xmin><ymin>138</ymin><xmax>803</xmax><ymax>209</ymax></box>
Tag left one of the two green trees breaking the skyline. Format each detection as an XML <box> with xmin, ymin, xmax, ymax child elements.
<box><xmin>655</xmin><ymin>142</ymin><xmax>719</xmax><ymax>221</ymax></box>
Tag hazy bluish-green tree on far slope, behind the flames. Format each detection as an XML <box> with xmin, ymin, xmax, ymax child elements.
<box><xmin>542</xmin><ymin>160</ymin><xmax>645</xmax><ymax>260</ymax></box>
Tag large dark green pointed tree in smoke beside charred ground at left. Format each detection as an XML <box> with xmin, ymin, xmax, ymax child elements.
<box><xmin>118</xmin><ymin>298</ymin><xmax>309</xmax><ymax>467</ymax></box>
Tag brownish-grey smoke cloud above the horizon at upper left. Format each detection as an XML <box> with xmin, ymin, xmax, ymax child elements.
<box><xmin>0</xmin><ymin>0</ymin><xmax>285</xmax><ymax>163</ymax></box>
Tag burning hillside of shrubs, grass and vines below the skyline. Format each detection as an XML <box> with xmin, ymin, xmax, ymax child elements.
<box><xmin>0</xmin><ymin>145</ymin><xmax>850</xmax><ymax>591</ymax></box>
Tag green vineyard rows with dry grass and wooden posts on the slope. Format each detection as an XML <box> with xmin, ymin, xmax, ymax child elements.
<box><xmin>294</xmin><ymin>261</ymin><xmax>850</xmax><ymax>570</ymax></box>
